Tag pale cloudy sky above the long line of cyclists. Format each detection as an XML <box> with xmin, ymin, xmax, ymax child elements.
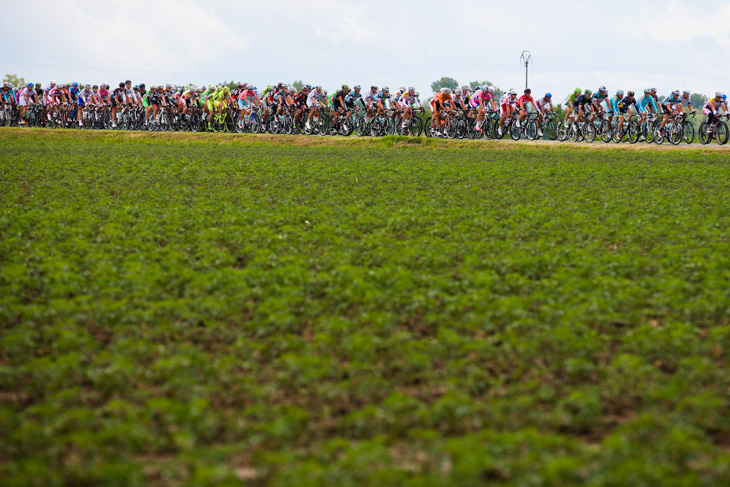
<box><xmin>0</xmin><ymin>0</ymin><xmax>730</xmax><ymax>98</ymax></box>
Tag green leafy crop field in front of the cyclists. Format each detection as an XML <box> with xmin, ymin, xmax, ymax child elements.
<box><xmin>0</xmin><ymin>129</ymin><xmax>730</xmax><ymax>487</ymax></box>
